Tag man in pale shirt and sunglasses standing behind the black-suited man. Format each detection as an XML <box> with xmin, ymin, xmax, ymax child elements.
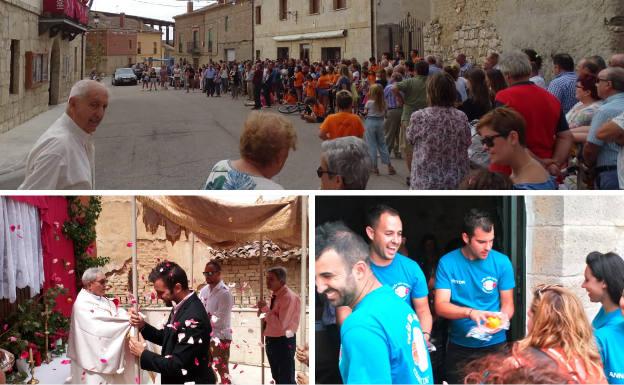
<box><xmin>199</xmin><ymin>261</ymin><xmax>234</xmax><ymax>384</ymax></box>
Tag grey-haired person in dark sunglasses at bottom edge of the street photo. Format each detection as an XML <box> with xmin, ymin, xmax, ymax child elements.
<box><xmin>316</xmin><ymin>136</ymin><xmax>371</xmax><ymax>190</ymax></box>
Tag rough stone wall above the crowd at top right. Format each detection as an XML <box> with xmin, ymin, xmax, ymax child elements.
<box><xmin>425</xmin><ymin>0</ymin><xmax>624</xmax><ymax>76</ymax></box>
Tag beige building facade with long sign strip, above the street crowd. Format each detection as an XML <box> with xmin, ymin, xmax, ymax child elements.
<box><xmin>254</xmin><ymin>0</ymin><xmax>371</xmax><ymax>61</ymax></box>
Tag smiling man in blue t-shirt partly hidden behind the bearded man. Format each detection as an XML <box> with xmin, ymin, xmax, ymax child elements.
<box><xmin>366</xmin><ymin>204</ymin><xmax>433</xmax><ymax>341</ymax></box>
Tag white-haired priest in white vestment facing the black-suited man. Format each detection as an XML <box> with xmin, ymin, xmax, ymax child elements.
<box><xmin>67</xmin><ymin>268</ymin><xmax>137</xmax><ymax>384</ymax></box>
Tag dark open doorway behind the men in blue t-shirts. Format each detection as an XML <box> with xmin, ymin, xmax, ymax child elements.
<box><xmin>315</xmin><ymin>196</ymin><xmax>526</xmax><ymax>341</ymax></box>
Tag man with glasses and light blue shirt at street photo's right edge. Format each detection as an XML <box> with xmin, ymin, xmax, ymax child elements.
<box><xmin>583</xmin><ymin>67</ymin><xmax>624</xmax><ymax>190</ymax></box>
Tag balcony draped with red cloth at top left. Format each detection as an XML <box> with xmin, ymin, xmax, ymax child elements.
<box><xmin>39</xmin><ymin>0</ymin><xmax>89</xmax><ymax>40</ymax></box>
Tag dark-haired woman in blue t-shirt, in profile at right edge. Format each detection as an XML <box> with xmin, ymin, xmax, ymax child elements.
<box><xmin>582</xmin><ymin>251</ymin><xmax>624</xmax><ymax>384</ymax></box>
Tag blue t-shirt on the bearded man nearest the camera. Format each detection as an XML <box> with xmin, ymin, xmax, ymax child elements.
<box><xmin>340</xmin><ymin>286</ymin><xmax>433</xmax><ymax>384</ymax></box>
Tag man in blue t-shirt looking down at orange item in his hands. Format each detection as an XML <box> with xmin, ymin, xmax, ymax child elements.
<box><xmin>435</xmin><ymin>209</ymin><xmax>515</xmax><ymax>384</ymax></box>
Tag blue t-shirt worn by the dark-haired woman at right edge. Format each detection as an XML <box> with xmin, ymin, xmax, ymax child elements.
<box><xmin>592</xmin><ymin>308</ymin><xmax>624</xmax><ymax>384</ymax></box>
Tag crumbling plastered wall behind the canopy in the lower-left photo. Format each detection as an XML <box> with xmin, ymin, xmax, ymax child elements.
<box><xmin>96</xmin><ymin>196</ymin><xmax>309</xmax><ymax>365</ymax></box>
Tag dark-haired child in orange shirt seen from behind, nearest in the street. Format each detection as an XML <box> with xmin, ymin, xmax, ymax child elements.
<box><xmin>319</xmin><ymin>90</ymin><xmax>364</xmax><ymax>140</ymax></box>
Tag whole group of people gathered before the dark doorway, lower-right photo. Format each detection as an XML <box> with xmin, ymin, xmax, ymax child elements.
<box><xmin>315</xmin><ymin>204</ymin><xmax>624</xmax><ymax>384</ymax></box>
